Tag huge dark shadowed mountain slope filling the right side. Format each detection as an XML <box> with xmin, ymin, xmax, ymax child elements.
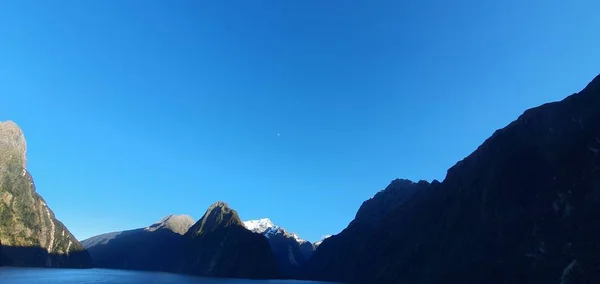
<box><xmin>303</xmin><ymin>76</ymin><xmax>600</xmax><ymax>284</ymax></box>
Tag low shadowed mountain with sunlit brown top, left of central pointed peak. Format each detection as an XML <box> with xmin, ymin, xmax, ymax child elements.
<box><xmin>81</xmin><ymin>215</ymin><xmax>194</xmax><ymax>271</ymax></box>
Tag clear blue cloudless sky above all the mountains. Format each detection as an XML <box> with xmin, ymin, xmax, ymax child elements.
<box><xmin>0</xmin><ymin>0</ymin><xmax>600</xmax><ymax>241</ymax></box>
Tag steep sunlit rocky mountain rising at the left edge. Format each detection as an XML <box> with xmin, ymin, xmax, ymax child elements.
<box><xmin>0</xmin><ymin>121</ymin><xmax>91</xmax><ymax>268</ymax></box>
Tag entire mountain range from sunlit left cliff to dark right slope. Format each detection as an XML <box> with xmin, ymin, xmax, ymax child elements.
<box><xmin>0</xmin><ymin>76</ymin><xmax>600</xmax><ymax>284</ymax></box>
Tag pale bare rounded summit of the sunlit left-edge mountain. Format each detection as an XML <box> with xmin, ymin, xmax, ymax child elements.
<box><xmin>0</xmin><ymin>120</ymin><xmax>27</xmax><ymax>168</ymax></box>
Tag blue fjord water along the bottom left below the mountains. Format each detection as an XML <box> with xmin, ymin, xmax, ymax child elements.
<box><xmin>0</xmin><ymin>267</ymin><xmax>326</xmax><ymax>284</ymax></box>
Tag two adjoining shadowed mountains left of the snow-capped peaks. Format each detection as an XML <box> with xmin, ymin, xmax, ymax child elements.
<box><xmin>82</xmin><ymin>202</ymin><xmax>278</xmax><ymax>278</ymax></box>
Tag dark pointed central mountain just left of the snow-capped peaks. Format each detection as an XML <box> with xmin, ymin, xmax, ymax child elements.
<box><xmin>173</xmin><ymin>202</ymin><xmax>279</xmax><ymax>279</ymax></box>
